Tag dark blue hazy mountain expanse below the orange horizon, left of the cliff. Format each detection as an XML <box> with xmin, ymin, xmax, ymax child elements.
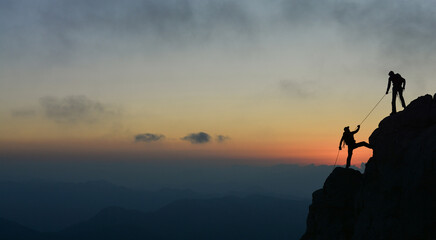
<box><xmin>0</xmin><ymin>157</ymin><xmax>331</xmax><ymax>239</ymax></box>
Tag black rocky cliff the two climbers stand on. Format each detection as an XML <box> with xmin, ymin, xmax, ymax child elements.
<box><xmin>301</xmin><ymin>94</ymin><xmax>436</xmax><ymax>240</ymax></box>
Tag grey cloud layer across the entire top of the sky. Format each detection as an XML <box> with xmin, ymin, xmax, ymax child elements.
<box><xmin>0</xmin><ymin>0</ymin><xmax>436</xmax><ymax>66</ymax></box>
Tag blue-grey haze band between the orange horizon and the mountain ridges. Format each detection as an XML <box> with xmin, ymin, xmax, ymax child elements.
<box><xmin>0</xmin><ymin>161</ymin><xmax>334</xmax><ymax>199</ymax></box>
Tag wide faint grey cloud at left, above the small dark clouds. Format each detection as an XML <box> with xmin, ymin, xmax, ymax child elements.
<box><xmin>39</xmin><ymin>95</ymin><xmax>120</xmax><ymax>124</ymax></box>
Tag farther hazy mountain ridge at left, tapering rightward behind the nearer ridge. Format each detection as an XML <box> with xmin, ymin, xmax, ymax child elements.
<box><xmin>0</xmin><ymin>181</ymin><xmax>210</xmax><ymax>231</ymax></box>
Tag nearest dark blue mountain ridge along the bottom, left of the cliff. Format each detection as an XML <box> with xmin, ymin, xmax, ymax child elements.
<box><xmin>61</xmin><ymin>196</ymin><xmax>308</xmax><ymax>240</ymax></box>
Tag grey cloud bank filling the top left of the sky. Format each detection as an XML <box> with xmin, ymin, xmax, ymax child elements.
<box><xmin>0</xmin><ymin>0</ymin><xmax>253</xmax><ymax>58</ymax></box>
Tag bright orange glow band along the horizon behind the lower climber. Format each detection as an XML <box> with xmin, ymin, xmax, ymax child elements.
<box><xmin>0</xmin><ymin>137</ymin><xmax>372</xmax><ymax>167</ymax></box>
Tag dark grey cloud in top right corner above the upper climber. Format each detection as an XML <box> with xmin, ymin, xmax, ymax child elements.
<box><xmin>281</xmin><ymin>0</ymin><xmax>436</xmax><ymax>57</ymax></box>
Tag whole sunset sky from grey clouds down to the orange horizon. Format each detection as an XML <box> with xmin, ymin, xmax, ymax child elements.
<box><xmin>0</xmin><ymin>0</ymin><xmax>436</xmax><ymax>169</ymax></box>
